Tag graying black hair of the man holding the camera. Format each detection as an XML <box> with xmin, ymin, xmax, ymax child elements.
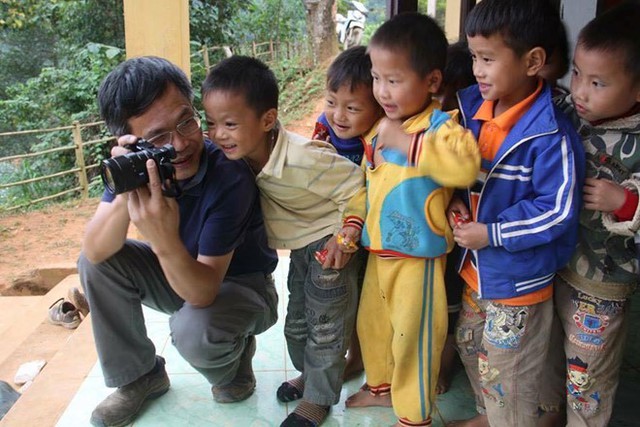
<box><xmin>98</xmin><ymin>56</ymin><xmax>193</xmax><ymax>136</ymax></box>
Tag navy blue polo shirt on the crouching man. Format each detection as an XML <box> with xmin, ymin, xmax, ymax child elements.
<box><xmin>102</xmin><ymin>141</ymin><xmax>278</xmax><ymax>276</ymax></box>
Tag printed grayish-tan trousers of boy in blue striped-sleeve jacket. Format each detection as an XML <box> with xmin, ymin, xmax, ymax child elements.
<box><xmin>456</xmin><ymin>292</ymin><xmax>553</xmax><ymax>427</ymax></box>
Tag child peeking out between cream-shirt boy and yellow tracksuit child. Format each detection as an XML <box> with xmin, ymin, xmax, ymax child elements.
<box><xmin>312</xmin><ymin>46</ymin><xmax>382</xmax><ymax>381</ymax></box>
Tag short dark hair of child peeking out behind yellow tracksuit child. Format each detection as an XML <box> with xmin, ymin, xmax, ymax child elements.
<box><xmin>327</xmin><ymin>46</ymin><xmax>373</xmax><ymax>92</ymax></box>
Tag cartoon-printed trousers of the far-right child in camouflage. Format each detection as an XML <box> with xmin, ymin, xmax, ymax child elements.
<box><xmin>541</xmin><ymin>277</ymin><xmax>630</xmax><ymax>427</ymax></box>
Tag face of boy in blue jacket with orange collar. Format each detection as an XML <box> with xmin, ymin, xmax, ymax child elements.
<box><xmin>467</xmin><ymin>34</ymin><xmax>531</xmax><ymax>112</ymax></box>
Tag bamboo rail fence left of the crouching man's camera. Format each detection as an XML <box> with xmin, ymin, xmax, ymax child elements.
<box><xmin>0</xmin><ymin>121</ymin><xmax>115</xmax><ymax>212</ymax></box>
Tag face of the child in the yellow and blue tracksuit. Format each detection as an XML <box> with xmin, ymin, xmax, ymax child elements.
<box><xmin>370</xmin><ymin>47</ymin><xmax>442</xmax><ymax>120</ymax></box>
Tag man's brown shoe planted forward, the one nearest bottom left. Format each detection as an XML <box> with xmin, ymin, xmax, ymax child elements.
<box><xmin>91</xmin><ymin>356</ymin><xmax>170</xmax><ymax>427</ymax></box>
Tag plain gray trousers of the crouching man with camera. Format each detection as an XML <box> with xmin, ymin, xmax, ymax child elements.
<box><xmin>78</xmin><ymin>240</ymin><xmax>278</xmax><ymax>387</ymax></box>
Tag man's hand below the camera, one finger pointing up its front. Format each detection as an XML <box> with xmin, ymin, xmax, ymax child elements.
<box><xmin>128</xmin><ymin>159</ymin><xmax>180</xmax><ymax>256</ymax></box>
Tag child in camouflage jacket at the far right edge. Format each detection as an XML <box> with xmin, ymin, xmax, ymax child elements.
<box><xmin>541</xmin><ymin>3</ymin><xmax>640</xmax><ymax>426</ymax></box>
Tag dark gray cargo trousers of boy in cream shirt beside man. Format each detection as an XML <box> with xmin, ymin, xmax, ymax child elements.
<box><xmin>284</xmin><ymin>236</ymin><xmax>364</xmax><ymax>406</ymax></box>
